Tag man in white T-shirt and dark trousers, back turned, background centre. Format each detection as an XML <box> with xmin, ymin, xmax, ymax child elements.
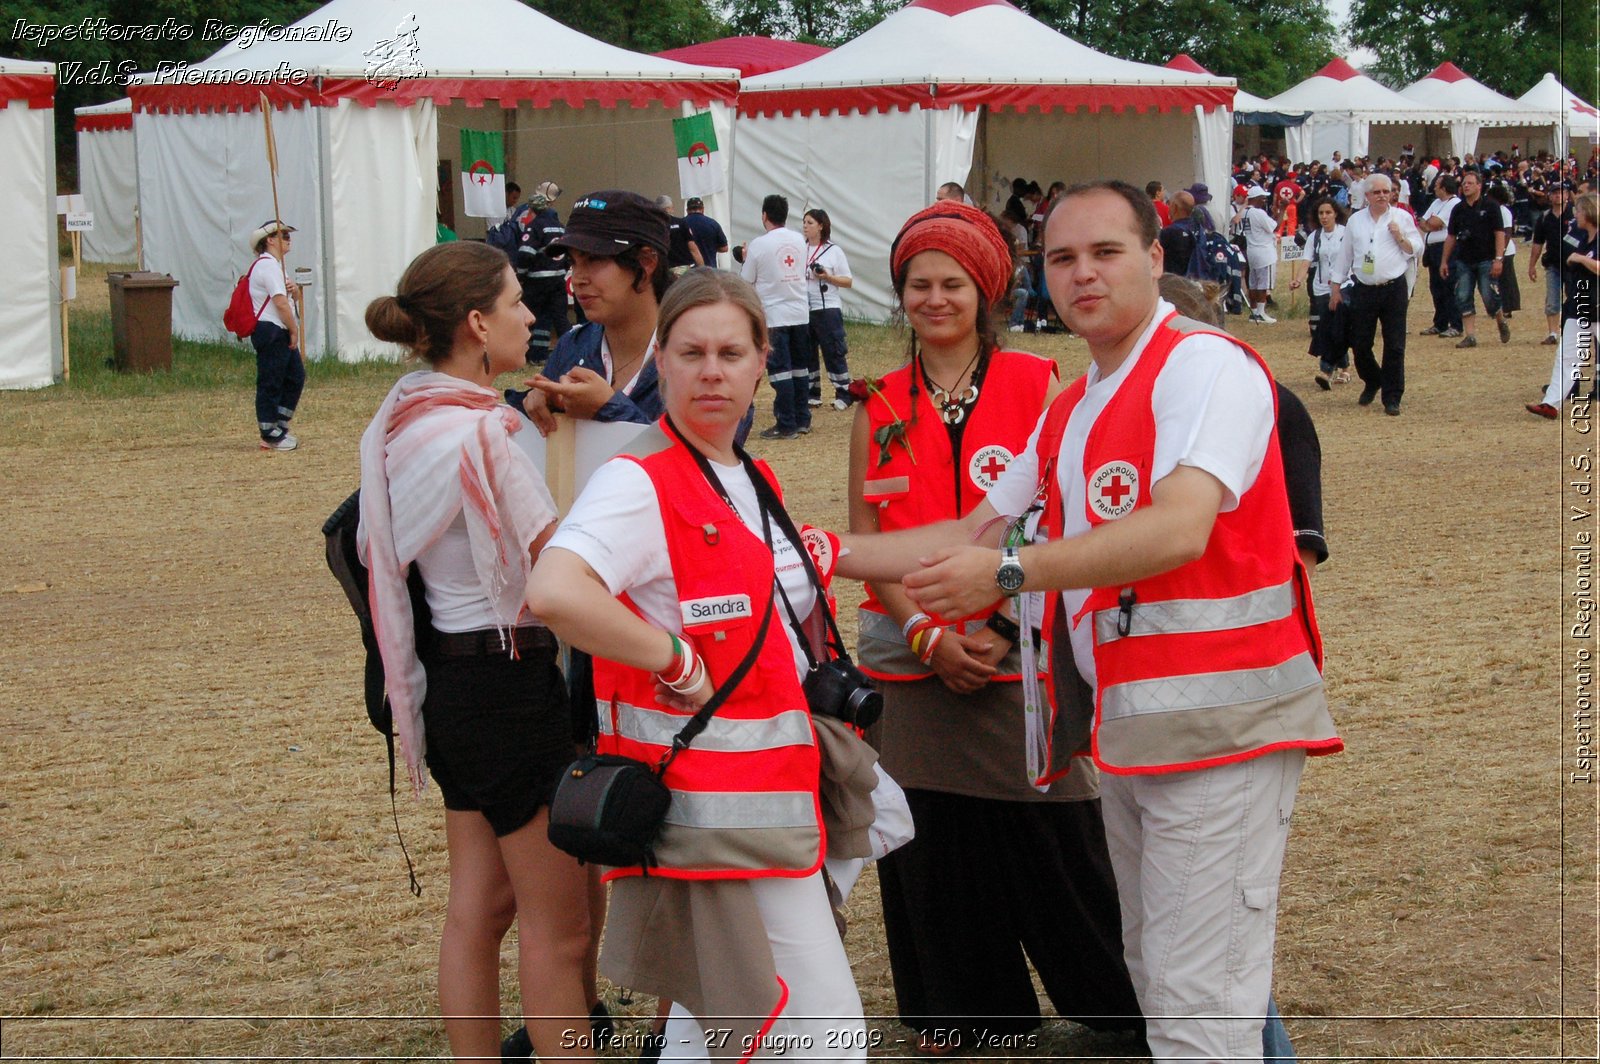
<box><xmin>739</xmin><ymin>195</ymin><xmax>811</xmax><ymax>440</ymax></box>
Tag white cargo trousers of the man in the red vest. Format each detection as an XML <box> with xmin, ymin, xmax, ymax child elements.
<box><xmin>1101</xmin><ymin>750</ymin><xmax>1306</xmax><ymax>1061</ymax></box>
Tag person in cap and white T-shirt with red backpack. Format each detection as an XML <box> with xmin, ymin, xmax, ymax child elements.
<box><xmin>250</xmin><ymin>218</ymin><xmax>306</xmax><ymax>451</ymax></box>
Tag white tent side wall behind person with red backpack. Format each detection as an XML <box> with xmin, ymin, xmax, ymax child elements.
<box><xmin>133</xmin><ymin>107</ymin><xmax>328</xmax><ymax>357</ymax></box>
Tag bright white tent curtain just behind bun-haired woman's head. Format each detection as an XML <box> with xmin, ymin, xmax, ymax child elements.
<box><xmin>321</xmin><ymin>99</ymin><xmax>438</xmax><ymax>362</ymax></box>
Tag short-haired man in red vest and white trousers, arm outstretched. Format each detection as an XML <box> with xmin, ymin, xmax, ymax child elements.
<box><xmin>838</xmin><ymin>181</ymin><xmax>1342</xmax><ymax>1061</ymax></box>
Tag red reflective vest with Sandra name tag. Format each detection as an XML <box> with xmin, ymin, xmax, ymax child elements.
<box><xmin>594</xmin><ymin>428</ymin><xmax>822</xmax><ymax>880</ymax></box>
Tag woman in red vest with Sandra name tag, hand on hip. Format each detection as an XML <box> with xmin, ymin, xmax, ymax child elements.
<box><xmin>528</xmin><ymin>269</ymin><xmax>869</xmax><ymax>1061</ymax></box>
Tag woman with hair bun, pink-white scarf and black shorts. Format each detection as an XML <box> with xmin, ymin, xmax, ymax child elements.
<box><xmin>358</xmin><ymin>242</ymin><xmax>589</xmax><ymax>1059</ymax></box>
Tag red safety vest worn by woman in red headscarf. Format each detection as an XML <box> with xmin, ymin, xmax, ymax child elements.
<box><xmin>858</xmin><ymin>350</ymin><xmax>1058</xmax><ymax>680</ymax></box>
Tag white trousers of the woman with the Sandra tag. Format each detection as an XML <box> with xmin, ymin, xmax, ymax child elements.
<box><xmin>661</xmin><ymin>872</ymin><xmax>870</xmax><ymax>1061</ymax></box>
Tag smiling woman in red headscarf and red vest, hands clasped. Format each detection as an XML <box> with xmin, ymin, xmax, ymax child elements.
<box><xmin>850</xmin><ymin>202</ymin><xmax>1142</xmax><ymax>1056</ymax></box>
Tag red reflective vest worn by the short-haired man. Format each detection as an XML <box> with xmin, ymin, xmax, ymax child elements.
<box><xmin>1038</xmin><ymin>314</ymin><xmax>1344</xmax><ymax>779</ymax></box>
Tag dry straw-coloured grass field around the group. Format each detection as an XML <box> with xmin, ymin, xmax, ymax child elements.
<box><xmin>0</xmin><ymin>260</ymin><xmax>1597</xmax><ymax>1061</ymax></box>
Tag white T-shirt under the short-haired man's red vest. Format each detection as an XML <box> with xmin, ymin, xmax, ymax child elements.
<box><xmin>989</xmin><ymin>299</ymin><xmax>1274</xmax><ymax>686</ymax></box>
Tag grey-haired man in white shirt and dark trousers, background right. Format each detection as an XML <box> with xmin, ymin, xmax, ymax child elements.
<box><xmin>1328</xmin><ymin>174</ymin><xmax>1422</xmax><ymax>418</ymax></box>
